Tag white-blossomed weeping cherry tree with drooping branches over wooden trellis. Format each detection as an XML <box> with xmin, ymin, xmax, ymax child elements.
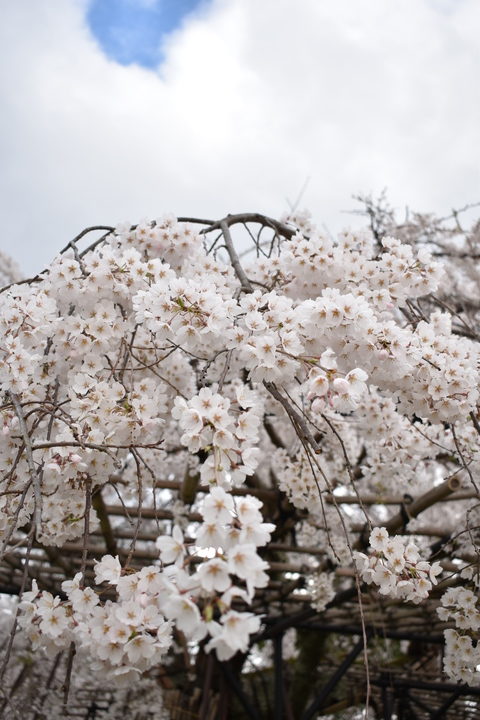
<box><xmin>0</xmin><ymin>198</ymin><xmax>480</xmax><ymax>720</ymax></box>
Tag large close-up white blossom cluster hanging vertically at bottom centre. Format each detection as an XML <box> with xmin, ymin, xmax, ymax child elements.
<box><xmin>157</xmin><ymin>487</ymin><xmax>275</xmax><ymax>660</ymax></box>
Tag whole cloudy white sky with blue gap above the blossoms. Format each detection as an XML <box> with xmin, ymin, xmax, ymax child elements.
<box><xmin>0</xmin><ymin>0</ymin><xmax>480</xmax><ymax>275</ymax></box>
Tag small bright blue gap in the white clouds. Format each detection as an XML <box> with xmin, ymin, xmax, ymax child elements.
<box><xmin>87</xmin><ymin>0</ymin><xmax>205</xmax><ymax>68</ymax></box>
